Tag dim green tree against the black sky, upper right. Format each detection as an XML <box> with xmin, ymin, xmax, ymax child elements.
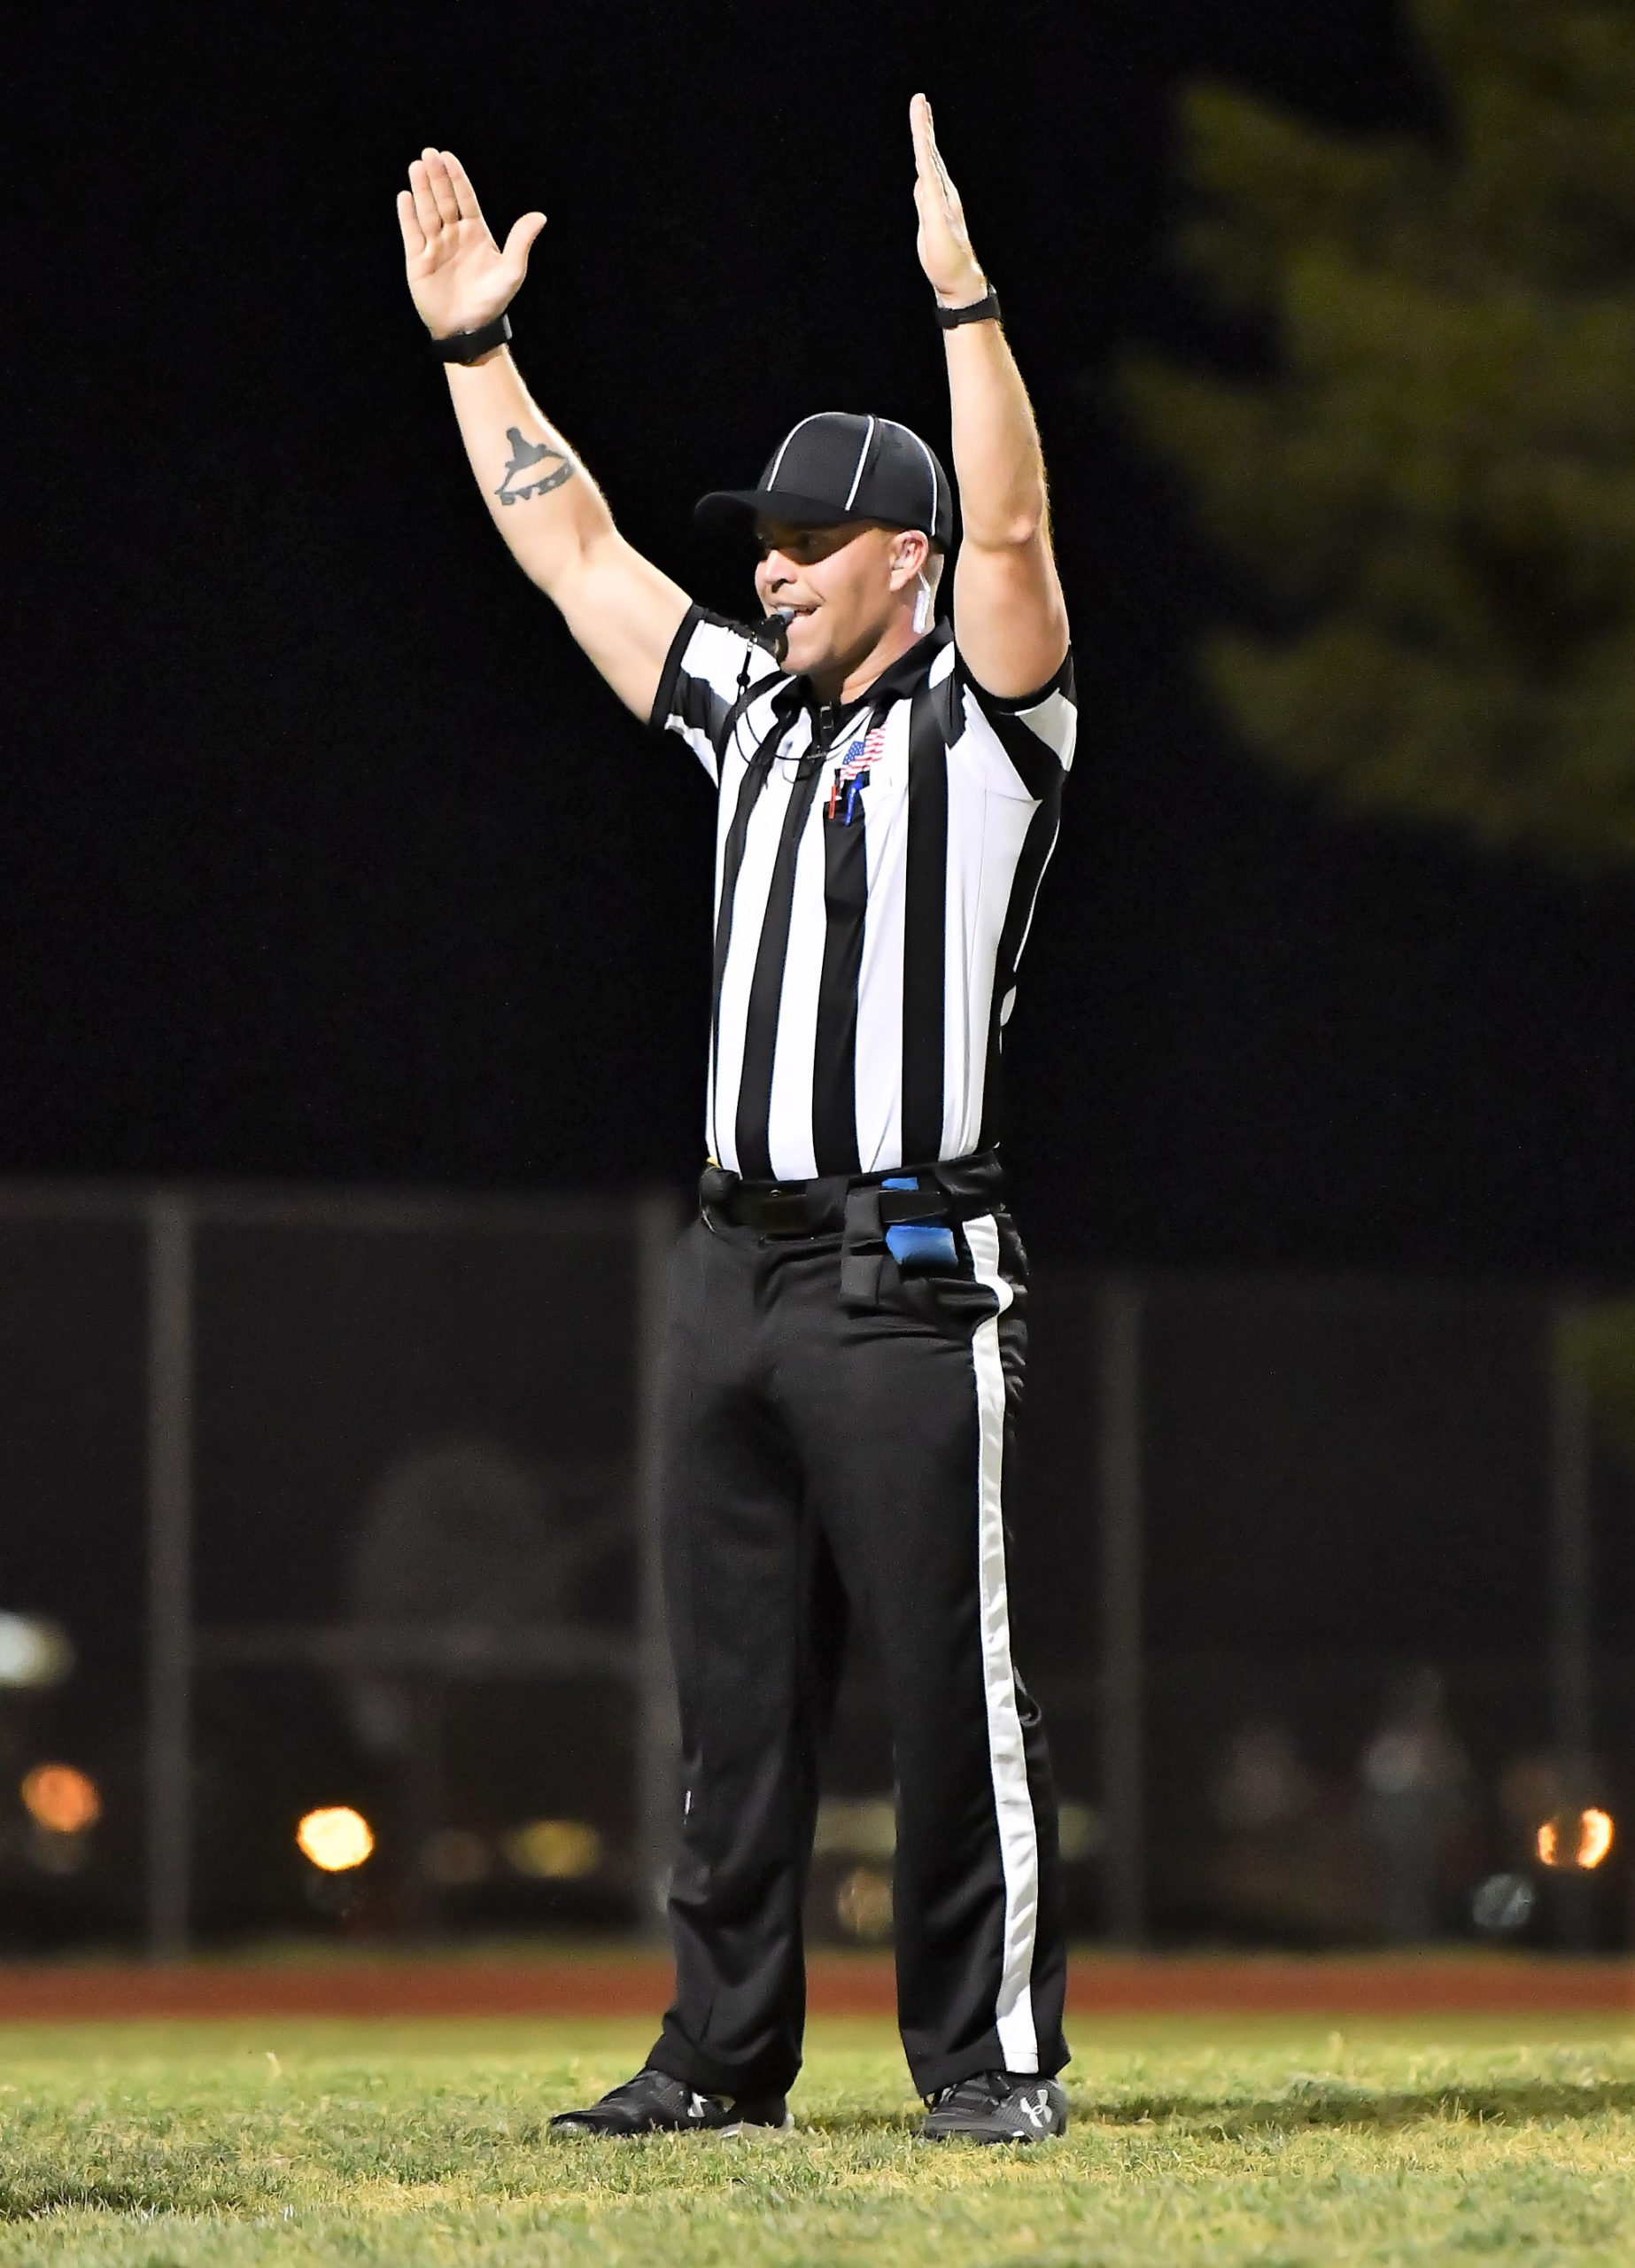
<box><xmin>1125</xmin><ymin>0</ymin><xmax>1635</xmax><ymax>862</ymax></box>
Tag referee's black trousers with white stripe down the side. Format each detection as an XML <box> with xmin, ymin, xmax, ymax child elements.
<box><xmin>651</xmin><ymin>1179</ymin><xmax>1068</xmax><ymax>2098</ymax></box>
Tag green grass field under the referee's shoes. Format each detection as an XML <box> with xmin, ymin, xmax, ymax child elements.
<box><xmin>0</xmin><ymin>2018</ymin><xmax>1635</xmax><ymax>2268</ymax></box>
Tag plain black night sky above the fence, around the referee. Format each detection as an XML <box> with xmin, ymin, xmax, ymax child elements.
<box><xmin>12</xmin><ymin>0</ymin><xmax>1635</xmax><ymax>1277</ymax></box>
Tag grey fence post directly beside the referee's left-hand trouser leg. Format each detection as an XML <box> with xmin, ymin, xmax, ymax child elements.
<box><xmin>635</xmin><ymin>1195</ymin><xmax>680</xmax><ymax>1937</ymax></box>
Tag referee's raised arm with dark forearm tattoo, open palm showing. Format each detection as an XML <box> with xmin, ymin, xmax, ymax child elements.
<box><xmin>397</xmin><ymin>150</ymin><xmax>687</xmax><ymax>717</ymax></box>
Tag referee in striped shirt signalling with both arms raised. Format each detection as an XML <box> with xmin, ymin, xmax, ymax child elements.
<box><xmin>397</xmin><ymin>96</ymin><xmax>1075</xmax><ymax>2141</ymax></box>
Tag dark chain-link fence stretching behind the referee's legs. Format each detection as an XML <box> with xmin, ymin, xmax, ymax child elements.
<box><xmin>0</xmin><ymin>1186</ymin><xmax>1635</xmax><ymax>1953</ymax></box>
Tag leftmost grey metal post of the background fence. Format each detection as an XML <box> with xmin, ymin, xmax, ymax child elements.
<box><xmin>145</xmin><ymin>1195</ymin><xmax>193</xmax><ymax>1960</ymax></box>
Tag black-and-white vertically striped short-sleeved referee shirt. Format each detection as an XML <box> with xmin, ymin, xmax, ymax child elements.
<box><xmin>653</xmin><ymin>608</ymin><xmax>1077</xmax><ymax>1182</ymax></box>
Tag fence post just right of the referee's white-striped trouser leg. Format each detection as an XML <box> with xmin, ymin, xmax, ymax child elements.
<box><xmin>1097</xmin><ymin>1284</ymin><xmax>1145</xmax><ymax>1946</ymax></box>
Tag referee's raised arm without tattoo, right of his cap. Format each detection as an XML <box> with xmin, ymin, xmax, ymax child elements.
<box><xmin>910</xmin><ymin>96</ymin><xmax>1068</xmax><ymax>698</ymax></box>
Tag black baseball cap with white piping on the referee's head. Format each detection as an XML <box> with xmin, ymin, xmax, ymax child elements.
<box><xmin>694</xmin><ymin>410</ymin><xmax>955</xmax><ymax>551</ymax></box>
